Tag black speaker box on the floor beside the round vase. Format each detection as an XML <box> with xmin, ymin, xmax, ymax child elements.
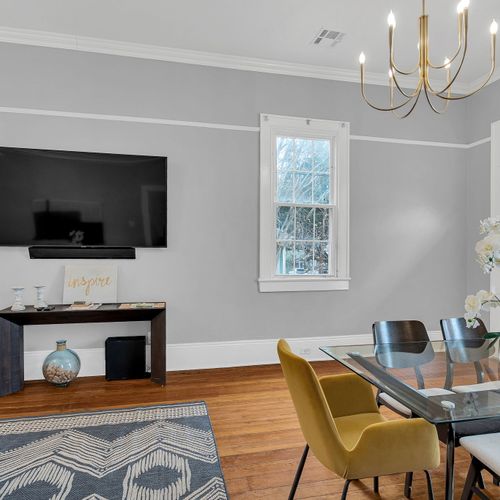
<box><xmin>105</xmin><ymin>336</ymin><xmax>150</xmax><ymax>380</ymax></box>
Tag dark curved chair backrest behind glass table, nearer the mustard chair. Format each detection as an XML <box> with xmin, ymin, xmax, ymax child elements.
<box><xmin>372</xmin><ymin>320</ymin><xmax>435</xmax><ymax>389</ymax></box>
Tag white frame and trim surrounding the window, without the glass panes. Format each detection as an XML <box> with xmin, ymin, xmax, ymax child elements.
<box><xmin>259</xmin><ymin>113</ymin><xmax>350</xmax><ymax>292</ymax></box>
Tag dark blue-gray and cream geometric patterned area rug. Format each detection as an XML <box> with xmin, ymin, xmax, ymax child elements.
<box><xmin>0</xmin><ymin>402</ymin><xmax>228</xmax><ymax>500</ymax></box>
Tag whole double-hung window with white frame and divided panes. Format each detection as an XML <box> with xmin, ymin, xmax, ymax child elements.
<box><xmin>259</xmin><ymin>114</ymin><xmax>349</xmax><ymax>292</ymax></box>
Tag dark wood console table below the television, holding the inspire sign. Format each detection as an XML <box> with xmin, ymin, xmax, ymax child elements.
<box><xmin>0</xmin><ymin>304</ymin><xmax>166</xmax><ymax>396</ymax></box>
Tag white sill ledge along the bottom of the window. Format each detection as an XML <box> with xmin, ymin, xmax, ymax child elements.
<box><xmin>259</xmin><ymin>276</ymin><xmax>351</xmax><ymax>292</ymax></box>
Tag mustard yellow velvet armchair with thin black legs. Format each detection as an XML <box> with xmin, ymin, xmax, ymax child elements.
<box><xmin>278</xmin><ymin>339</ymin><xmax>440</xmax><ymax>500</ymax></box>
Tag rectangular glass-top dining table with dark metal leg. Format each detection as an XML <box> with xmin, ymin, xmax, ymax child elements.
<box><xmin>320</xmin><ymin>337</ymin><xmax>500</xmax><ymax>500</ymax></box>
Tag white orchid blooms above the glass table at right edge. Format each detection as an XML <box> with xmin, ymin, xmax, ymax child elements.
<box><xmin>464</xmin><ymin>217</ymin><xmax>500</xmax><ymax>328</ymax></box>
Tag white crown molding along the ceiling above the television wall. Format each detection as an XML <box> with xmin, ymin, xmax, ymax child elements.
<box><xmin>0</xmin><ymin>27</ymin><xmax>470</xmax><ymax>94</ymax></box>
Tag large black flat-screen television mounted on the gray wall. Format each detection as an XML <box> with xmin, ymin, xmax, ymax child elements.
<box><xmin>0</xmin><ymin>147</ymin><xmax>167</xmax><ymax>247</ymax></box>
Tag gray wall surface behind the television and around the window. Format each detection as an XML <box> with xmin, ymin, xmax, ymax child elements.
<box><xmin>0</xmin><ymin>45</ymin><xmax>480</xmax><ymax>350</ymax></box>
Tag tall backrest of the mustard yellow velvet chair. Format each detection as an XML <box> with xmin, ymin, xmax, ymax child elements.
<box><xmin>278</xmin><ymin>339</ymin><xmax>348</xmax><ymax>475</ymax></box>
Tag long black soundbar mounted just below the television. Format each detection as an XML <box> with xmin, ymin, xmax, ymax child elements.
<box><xmin>28</xmin><ymin>245</ymin><xmax>135</xmax><ymax>259</ymax></box>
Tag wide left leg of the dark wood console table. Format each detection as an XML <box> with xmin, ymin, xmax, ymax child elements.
<box><xmin>0</xmin><ymin>318</ymin><xmax>24</xmax><ymax>396</ymax></box>
